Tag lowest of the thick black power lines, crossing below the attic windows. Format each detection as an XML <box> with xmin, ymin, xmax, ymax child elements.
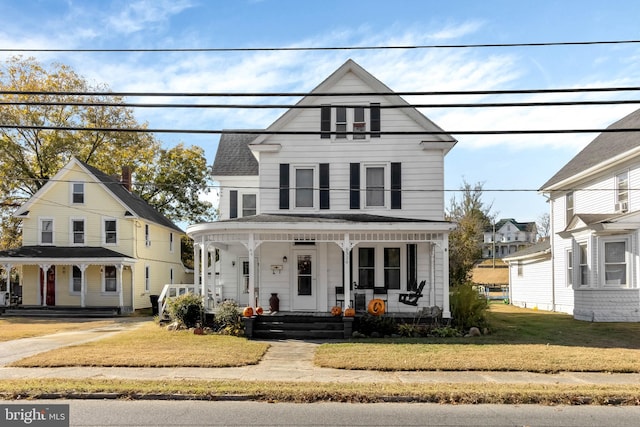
<box><xmin>0</xmin><ymin>124</ymin><xmax>640</xmax><ymax>136</ymax></box>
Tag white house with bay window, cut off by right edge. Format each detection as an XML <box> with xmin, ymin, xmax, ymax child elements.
<box><xmin>540</xmin><ymin>110</ymin><xmax>640</xmax><ymax>322</ymax></box>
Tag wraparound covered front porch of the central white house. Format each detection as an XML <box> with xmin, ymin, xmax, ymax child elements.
<box><xmin>187</xmin><ymin>214</ymin><xmax>453</xmax><ymax>318</ymax></box>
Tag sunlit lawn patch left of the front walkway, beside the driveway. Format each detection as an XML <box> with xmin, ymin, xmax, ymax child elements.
<box><xmin>11</xmin><ymin>322</ymin><xmax>269</xmax><ymax>368</ymax></box>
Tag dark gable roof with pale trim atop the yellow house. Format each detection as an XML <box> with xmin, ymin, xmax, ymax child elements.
<box><xmin>14</xmin><ymin>157</ymin><xmax>184</xmax><ymax>233</ymax></box>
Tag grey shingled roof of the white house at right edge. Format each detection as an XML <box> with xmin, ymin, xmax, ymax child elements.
<box><xmin>540</xmin><ymin>109</ymin><xmax>640</xmax><ymax>191</ymax></box>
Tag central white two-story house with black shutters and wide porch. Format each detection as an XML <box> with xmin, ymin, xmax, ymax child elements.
<box><xmin>187</xmin><ymin>60</ymin><xmax>456</xmax><ymax>317</ymax></box>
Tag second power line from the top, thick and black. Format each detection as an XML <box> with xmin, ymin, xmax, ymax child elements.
<box><xmin>0</xmin><ymin>86</ymin><xmax>640</xmax><ymax>98</ymax></box>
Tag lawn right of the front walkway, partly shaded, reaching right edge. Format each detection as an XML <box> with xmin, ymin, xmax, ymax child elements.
<box><xmin>315</xmin><ymin>304</ymin><xmax>640</xmax><ymax>373</ymax></box>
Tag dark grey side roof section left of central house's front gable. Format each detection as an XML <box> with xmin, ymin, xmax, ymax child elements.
<box><xmin>212</xmin><ymin>133</ymin><xmax>258</xmax><ymax>176</ymax></box>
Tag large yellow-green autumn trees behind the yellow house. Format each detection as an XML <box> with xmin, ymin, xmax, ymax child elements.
<box><xmin>0</xmin><ymin>57</ymin><xmax>213</xmax><ymax>248</ymax></box>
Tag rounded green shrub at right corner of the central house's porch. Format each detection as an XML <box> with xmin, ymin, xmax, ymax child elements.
<box><xmin>450</xmin><ymin>282</ymin><xmax>489</xmax><ymax>330</ymax></box>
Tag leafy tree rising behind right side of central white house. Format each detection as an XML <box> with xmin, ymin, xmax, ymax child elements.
<box><xmin>446</xmin><ymin>181</ymin><xmax>491</xmax><ymax>285</ymax></box>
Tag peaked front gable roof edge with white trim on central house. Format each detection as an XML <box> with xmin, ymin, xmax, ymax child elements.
<box><xmin>253</xmin><ymin>59</ymin><xmax>457</xmax><ymax>149</ymax></box>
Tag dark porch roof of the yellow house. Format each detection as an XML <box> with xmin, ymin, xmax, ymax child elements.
<box><xmin>0</xmin><ymin>246</ymin><xmax>135</xmax><ymax>265</ymax></box>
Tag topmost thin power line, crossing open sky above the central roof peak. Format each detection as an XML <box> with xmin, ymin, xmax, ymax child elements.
<box><xmin>0</xmin><ymin>40</ymin><xmax>640</xmax><ymax>53</ymax></box>
